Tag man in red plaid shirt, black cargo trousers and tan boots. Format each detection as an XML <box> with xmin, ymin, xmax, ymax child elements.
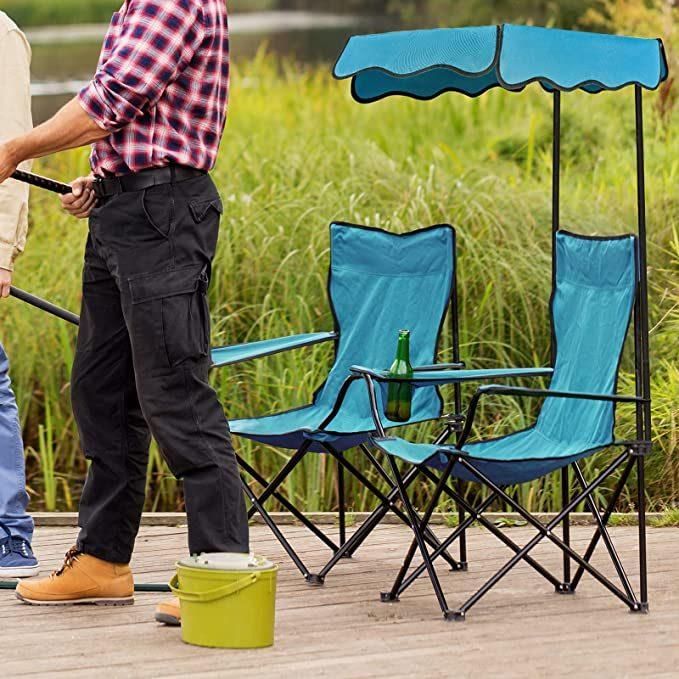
<box><xmin>0</xmin><ymin>0</ymin><xmax>248</xmax><ymax>617</ymax></box>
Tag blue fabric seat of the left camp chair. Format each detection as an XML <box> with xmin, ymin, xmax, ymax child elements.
<box><xmin>230</xmin><ymin>403</ymin><xmax>436</xmax><ymax>453</ymax></box>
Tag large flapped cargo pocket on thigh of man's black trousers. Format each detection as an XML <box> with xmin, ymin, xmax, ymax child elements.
<box><xmin>129</xmin><ymin>264</ymin><xmax>210</xmax><ymax>368</ymax></box>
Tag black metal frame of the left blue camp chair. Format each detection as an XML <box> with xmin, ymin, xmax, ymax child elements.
<box><xmin>237</xmin><ymin>222</ymin><xmax>467</xmax><ymax>586</ymax></box>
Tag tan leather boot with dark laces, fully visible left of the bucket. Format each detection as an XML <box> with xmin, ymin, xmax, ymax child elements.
<box><xmin>16</xmin><ymin>547</ymin><xmax>134</xmax><ymax>606</ymax></box>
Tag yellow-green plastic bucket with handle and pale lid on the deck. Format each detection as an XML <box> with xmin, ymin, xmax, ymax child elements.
<box><xmin>170</xmin><ymin>557</ymin><xmax>278</xmax><ymax>648</ymax></box>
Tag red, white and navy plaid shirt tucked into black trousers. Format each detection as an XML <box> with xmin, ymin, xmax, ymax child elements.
<box><xmin>78</xmin><ymin>0</ymin><xmax>229</xmax><ymax>175</ymax></box>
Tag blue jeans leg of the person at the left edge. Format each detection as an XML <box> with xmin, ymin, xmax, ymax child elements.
<box><xmin>0</xmin><ymin>344</ymin><xmax>33</xmax><ymax>542</ymax></box>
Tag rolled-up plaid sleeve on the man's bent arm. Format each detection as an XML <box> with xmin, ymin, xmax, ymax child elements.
<box><xmin>78</xmin><ymin>0</ymin><xmax>205</xmax><ymax>132</ymax></box>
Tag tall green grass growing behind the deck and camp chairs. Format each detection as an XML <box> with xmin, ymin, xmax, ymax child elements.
<box><xmin>0</xmin><ymin>55</ymin><xmax>679</xmax><ymax>510</ymax></box>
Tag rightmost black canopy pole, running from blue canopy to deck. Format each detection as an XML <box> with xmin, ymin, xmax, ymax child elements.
<box><xmin>634</xmin><ymin>85</ymin><xmax>651</xmax><ymax>612</ymax></box>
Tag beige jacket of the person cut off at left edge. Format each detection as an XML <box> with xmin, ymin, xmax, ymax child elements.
<box><xmin>0</xmin><ymin>21</ymin><xmax>33</xmax><ymax>271</ymax></box>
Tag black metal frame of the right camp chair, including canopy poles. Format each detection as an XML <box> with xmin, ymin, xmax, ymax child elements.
<box><xmin>362</xmin><ymin>85</ymin><xmax>652</xmax><ymax>621</ymax></box>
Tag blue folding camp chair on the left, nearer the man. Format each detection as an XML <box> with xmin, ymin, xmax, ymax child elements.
<box><xmin>213</xmin><ymin>223</ymin><xmax>545</xmax><ymax>584</ymax></box>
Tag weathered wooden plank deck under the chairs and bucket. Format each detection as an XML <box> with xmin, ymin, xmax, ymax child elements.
<box><xmin>0</xmin><ymin>526</ymin><xmax>679</xmax><ymax>679</ymax></box>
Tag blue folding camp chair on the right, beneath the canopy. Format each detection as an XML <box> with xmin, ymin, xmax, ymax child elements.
<box><xmin>353</xmin><ymin>231</ymin><xmax>649</xmax><ymax>620</ymax></box>
